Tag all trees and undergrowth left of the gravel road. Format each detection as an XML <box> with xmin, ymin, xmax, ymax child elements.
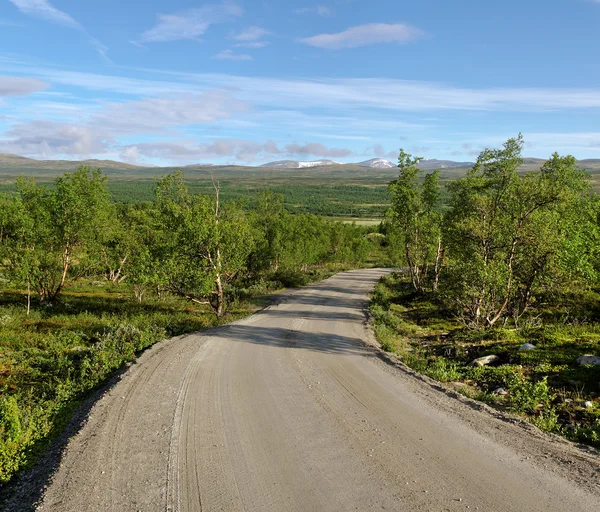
<box><xmin>0</xmin><ymin>171</ymin><xmax>380</xmax><ymax>485</ymax></box>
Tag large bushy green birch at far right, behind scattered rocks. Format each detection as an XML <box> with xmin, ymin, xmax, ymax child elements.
<box><xmin>442</xmin><ymin>135</ymin><xmax>598</xmax><ymax>327</ymax></box>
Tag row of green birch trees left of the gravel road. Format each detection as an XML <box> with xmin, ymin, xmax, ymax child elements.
<box><xmin>0</xmin><ymin>167</ymin><xmax>373</xmax><ymax>316</ymax></box>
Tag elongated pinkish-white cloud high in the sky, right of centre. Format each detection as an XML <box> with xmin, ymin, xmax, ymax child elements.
<box><xmin>300</xmin><ymin>23</ymin><xmax>425</xmax><ymax>50</ymax></box>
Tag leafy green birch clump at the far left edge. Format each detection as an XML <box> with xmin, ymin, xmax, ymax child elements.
<box><xmin>0</xmin><ymin>167</ymin><xmax>114</xmax><ymax>301</ymax></box>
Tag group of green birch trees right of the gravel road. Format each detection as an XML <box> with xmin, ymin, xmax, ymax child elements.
<box><xmin>384</xmin><ymin>135</ymin><xmax>600</xmax><ymax>328</ymax></box>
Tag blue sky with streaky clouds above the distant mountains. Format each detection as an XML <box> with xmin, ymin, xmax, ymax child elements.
<box><xmin>0</xmin><ymin>0</ymin><xmax>600</xmax><ymax>165</ymax></box>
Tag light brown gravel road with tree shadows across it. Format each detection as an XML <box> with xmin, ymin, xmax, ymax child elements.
<box><xmin>27</xmin><ymin>269</ymin><xmax>600</xmax><ymax>512</ymax></box>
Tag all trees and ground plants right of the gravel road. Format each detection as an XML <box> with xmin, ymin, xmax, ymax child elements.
<box><xmin>370</xmin><ymin>136</ymin><xmax>600</xmax><ymax>448</ymax></box>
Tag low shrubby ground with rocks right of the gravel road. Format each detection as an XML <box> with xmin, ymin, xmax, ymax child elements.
<box><xmin>370</xmin><ymin>274</ymin><xmax>600</xmax><ymax>448</ymax></box>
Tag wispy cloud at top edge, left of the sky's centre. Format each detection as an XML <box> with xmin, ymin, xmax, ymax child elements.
<box><xmin>140</xmin><ymin>1</ymin><xmax>243</xmax><ymax>43</ymax></box>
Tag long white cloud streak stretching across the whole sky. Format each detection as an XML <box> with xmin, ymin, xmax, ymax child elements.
<box><xmin>0</xmin><ymin>63</ymin><xmax>600</xmax><ymax>115</ymax></box>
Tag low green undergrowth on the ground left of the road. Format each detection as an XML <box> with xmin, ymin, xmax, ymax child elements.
<box><xmin>0</xmin><ymin>285</ymin><xmax>254</xmax><ymax>483</ymax></box>
